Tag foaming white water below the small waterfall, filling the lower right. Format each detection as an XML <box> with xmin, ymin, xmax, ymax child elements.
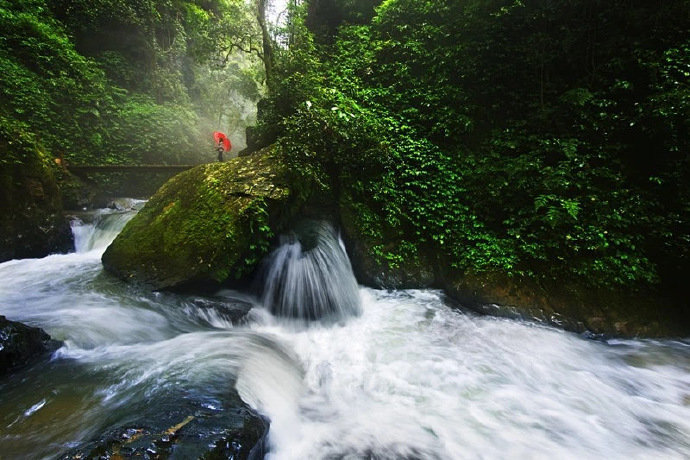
<box><xmin>255</xmin><ymin>290</ymin><xmax>690</xmax><ymax>459</ymax></box>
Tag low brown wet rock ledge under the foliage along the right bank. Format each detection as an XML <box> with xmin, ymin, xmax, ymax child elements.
<box><xmin>440</xmin><ymin>270</ymin><xmax>690</xmax><ymax>337</ymax></box>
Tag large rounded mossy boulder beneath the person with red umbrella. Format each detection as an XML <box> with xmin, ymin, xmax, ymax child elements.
<box><xmin>102</xmin><ymin>148</ymin><xmax>293</xmax><ymax>290</ymax></box>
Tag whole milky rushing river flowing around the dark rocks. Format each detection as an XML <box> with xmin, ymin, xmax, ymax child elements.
<box><xmin>0</xmin><ymin>203</ymin><xmax>690</xmax><ymax>459</ymax></box>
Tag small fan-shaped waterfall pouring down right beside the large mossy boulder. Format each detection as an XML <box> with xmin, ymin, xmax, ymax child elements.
<box><xmin>261</xmin><ymin>221</ymin><xmax>361</xmax><ymax>320</ymax></box>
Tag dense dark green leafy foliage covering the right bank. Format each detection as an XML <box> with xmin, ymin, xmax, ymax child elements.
<box><xmin>254</xmin><ymin>0</ymin><xmax>690</xmax><ymax>298</ymax></box>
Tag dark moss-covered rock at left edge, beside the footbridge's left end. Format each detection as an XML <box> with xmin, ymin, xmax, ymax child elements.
<box><xmin>0</xmin><ymin>136</ymin><xmax>74</xmax><ymax>262</ymax></box>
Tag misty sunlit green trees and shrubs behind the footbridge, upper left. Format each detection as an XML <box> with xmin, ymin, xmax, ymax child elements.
<box><xmin>0</xmin><ymin>0</ymin><xmax>261</xmax><ymax>164</ymax></box>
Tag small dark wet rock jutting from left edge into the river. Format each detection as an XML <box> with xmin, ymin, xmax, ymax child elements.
<box><xmin>0</xmin><ymin>316</ymin><xmax>60</xmax><ymax>375</ymax></box>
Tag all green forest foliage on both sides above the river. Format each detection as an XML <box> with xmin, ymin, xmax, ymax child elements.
<box><xmin>0</xmin><ymin>0</ymin><xmax>690</xmax><ymax>326</ymax></box>
